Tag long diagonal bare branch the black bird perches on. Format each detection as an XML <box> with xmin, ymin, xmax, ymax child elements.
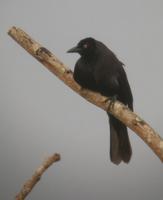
<box><xmin>8</xmin><ymin>27</ymin><xmax>163</xmax><ymax>161</ymax></box>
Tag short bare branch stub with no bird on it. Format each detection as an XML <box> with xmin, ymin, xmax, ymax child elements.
<box><xmin>15</xmin><ymin>154</ymin><xmax>60</xmax><ymax>200</ymax></box>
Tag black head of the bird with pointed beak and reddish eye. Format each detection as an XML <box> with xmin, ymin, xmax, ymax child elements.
<box><xmin>67</xmin><ymin>37</ymin><xmax>96</xmax><ymax>56</ymax></box>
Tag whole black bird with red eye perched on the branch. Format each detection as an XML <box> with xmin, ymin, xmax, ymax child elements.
<box><xmin>68</xmin><ymin>38</ymin><xmax>133</xmax><ymax>164</ymax></box>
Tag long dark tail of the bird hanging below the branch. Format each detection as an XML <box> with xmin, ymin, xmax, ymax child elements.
<box><xmin>108</xmin><ymin>111</ymin><xmax>132</xmax><ymax>165</ymax></box>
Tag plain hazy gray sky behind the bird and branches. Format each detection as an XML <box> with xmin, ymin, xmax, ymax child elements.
<box><xmin>0</xmin><ymin>0</ymin><xmax>163</xmax><ymax>200</ymax></box>
